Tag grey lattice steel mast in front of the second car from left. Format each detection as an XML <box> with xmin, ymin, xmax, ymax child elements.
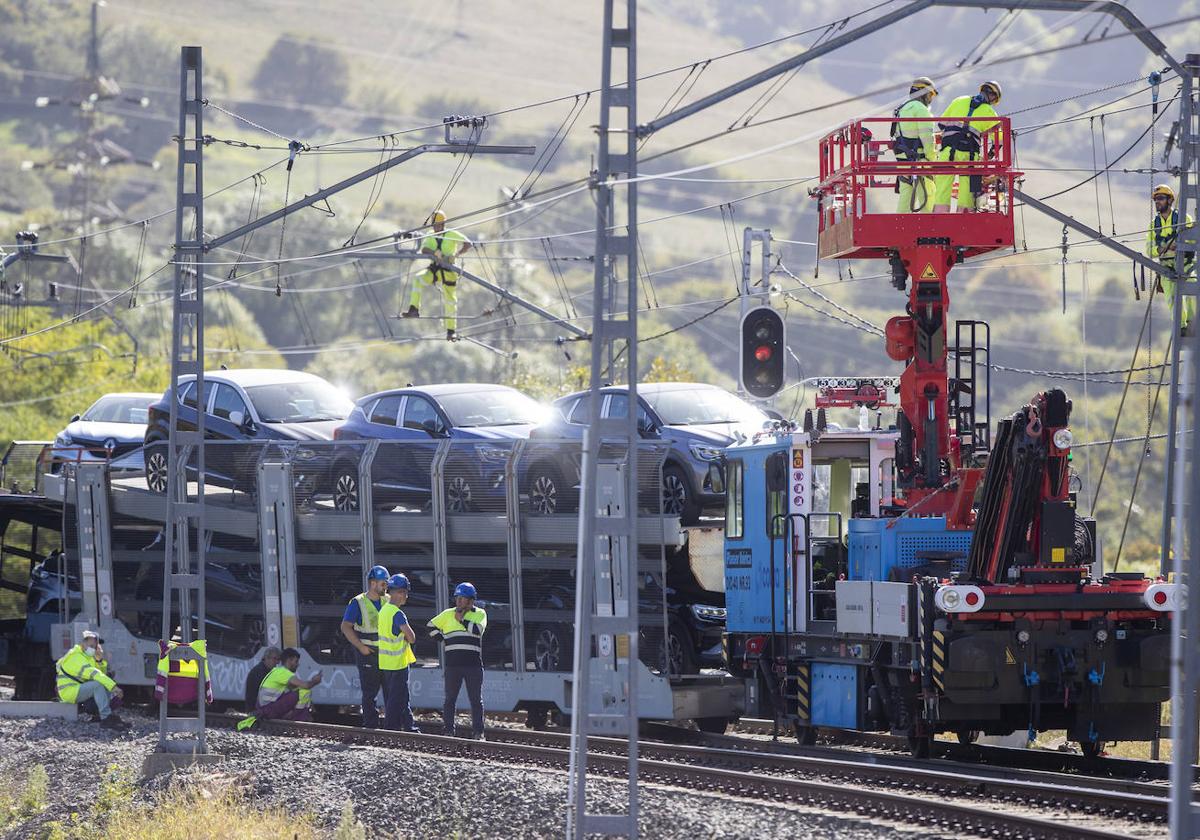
<box><xmin>158</xmin><ymin>47</ymin><xmax>206</xmax><ymax>754</ymax></box>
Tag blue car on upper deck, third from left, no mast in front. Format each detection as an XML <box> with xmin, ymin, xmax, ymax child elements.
<box><xmin>332</xmin><ymin>383</ymin><xmax>551</xmax><ymax>514</ymax></box>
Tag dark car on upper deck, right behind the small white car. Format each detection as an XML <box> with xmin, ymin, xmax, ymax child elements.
<box><xmin>145</xmin><ymin>370</ymin><xmax>354</xmax><ymax>497</ymax></box>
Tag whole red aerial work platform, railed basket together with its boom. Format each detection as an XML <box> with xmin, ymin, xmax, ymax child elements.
<box><xmin>812</xmin><ymin>116</ymin><xmax>1021</xmax><ymax>527</ymax></box>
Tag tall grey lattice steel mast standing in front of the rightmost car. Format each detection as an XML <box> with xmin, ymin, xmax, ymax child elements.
<box><xmin>566</xmin><ymin>0</ymin><xmax>638</xmax><ymax>838</ymax></box>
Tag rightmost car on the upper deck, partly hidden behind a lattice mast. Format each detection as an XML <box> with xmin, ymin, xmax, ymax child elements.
<box><xmin>524</xmin><ymin>382</ymin><xmax>769</xmax><ymax>524</ymax></box>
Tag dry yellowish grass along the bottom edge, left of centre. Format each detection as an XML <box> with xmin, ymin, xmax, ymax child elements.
<box><xmin>43</xmin><ymin>766</ymin><xmax>321</xmax><ymax>840</ymax></box>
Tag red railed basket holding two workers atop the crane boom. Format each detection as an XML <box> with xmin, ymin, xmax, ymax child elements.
<box><xmin>812</xmin><ymin>116</ymin><xmax>1021</xmax><ymax>259</ymax></box>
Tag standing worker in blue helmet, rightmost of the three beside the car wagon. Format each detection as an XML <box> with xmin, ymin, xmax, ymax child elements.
<box><xmin>428</xmin><ymin>583</ymin><xmax>487</xmax><ymax>740</ymax></box>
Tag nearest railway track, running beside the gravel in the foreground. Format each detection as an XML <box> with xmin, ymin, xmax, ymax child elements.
<box><xmin>210</xmin><ymin>715</ymin><xmax>1166</xmax><ymax>840</ymax></box>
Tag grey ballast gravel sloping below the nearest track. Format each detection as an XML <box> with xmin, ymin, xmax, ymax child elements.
<box><xmin>0</xmin><ymin>715</ymin><xmax>949</xmax><ymax>840</ymax></box>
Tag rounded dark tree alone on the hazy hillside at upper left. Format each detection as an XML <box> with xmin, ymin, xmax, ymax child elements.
<box><xmin>253</xmin><ymin>35</ymin><xmax>350</xmax><ymax>104</ymax></box>
